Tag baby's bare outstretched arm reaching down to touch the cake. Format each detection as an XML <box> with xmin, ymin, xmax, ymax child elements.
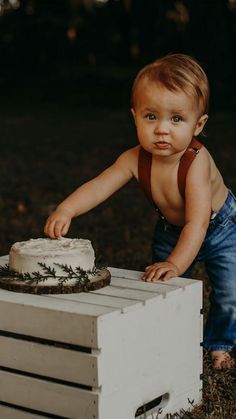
<box><xmin>44</xmin><ymin>147</ymin><xmax>137</xmax><ymax>239</ymax></box>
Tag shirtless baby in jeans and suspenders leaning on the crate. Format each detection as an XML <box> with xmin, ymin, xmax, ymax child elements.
<box><xmin>45</xmin><ymin>54</ymin><xmax>236</xmax><ymax>368</ymax></box>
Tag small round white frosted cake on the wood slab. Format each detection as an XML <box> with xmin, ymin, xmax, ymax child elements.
<box><xmin>9</xmin><ymin>238</ymin><xmax>95</xmax><ymax>282</ymax></box>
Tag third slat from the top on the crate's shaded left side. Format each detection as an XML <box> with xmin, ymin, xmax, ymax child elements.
<box><xmin>0</xmin><ymin>371</ymin><xmax>99</xmax><ymax>419</ymax></box>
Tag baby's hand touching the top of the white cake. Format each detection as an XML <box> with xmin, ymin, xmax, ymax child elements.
<box><xmin>44</xmin><ymin>210</ymin><xmax>72</xmax><ymax>239</ymax></box>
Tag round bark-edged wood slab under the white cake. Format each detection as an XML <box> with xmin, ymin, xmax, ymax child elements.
<box><xmin>0</xmin><ymin>268</ymin><xmax>111</xmax><ymax>294</ymax></box>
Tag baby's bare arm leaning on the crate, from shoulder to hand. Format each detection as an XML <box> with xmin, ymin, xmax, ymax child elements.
<box><xmin>144</xmin><ymin>149</ymin><xmax>212</xmax><ymax>281</ymax></box>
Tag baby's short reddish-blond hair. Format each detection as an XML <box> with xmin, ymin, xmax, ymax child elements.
<box><xmin>131</xmin><ymin>54</ymin><xmax>209</xmax><ymax>115</ymax></box>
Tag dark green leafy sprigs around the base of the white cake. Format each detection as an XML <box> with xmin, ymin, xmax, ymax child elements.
<box><xmin>0</xmin><ymin>263</ymin><xmax>100</xmax><ymax>286</ymax></box>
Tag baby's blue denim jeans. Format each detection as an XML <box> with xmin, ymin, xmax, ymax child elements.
<box><xmin>152</xmin><ymin>191</ymin><xmax>236</xmax><ymax>351</ymax></box>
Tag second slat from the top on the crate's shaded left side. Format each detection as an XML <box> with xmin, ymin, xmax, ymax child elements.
<box><xmin>0</xmin><ymin>336</ymin><xmax>100</xmax><ymax>387</ymax></box>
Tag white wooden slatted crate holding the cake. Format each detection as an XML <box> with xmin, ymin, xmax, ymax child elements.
<box><xmin>0</xmin><ymin>257</ymin><xmax>202</xmax><ymax>419</ymax></box>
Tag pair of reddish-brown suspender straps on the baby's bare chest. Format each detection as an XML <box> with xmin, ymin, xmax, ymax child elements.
<box><xmin>138</xmin><ymin>137</ymin><xmax>202</xmax><ymax>208</ymax></box>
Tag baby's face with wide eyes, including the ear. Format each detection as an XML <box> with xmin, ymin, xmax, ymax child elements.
<box><xmin>132</xmin><ymin>79</ymin><xmax>207</xmax><ymax>156</ymax></box>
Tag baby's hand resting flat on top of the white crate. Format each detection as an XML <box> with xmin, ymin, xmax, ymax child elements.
<box><xmin>143</xmin><ymin>261</ymin><xmax>179</xmax><ymax>282</ymax></box>
